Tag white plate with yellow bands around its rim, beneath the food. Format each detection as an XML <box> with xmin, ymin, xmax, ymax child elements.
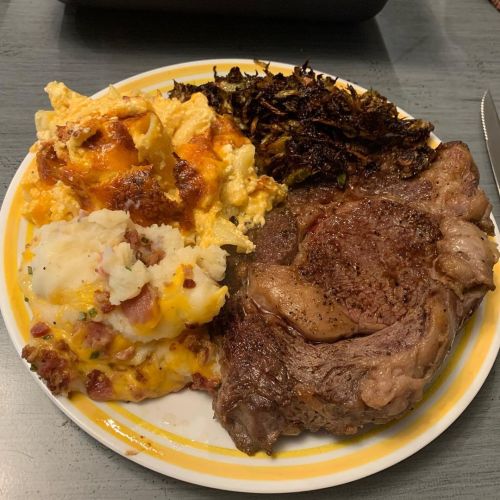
<box><xmin>0</xmin><ymin>59</ymin><xmax>500</xmax><ymax>493</ymax></box>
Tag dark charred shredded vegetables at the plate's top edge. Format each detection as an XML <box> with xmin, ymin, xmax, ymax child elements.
<box><xmin>171</xmin><ymin>64</ymin><xmax>435</xmax><ymax>187</ymax></box>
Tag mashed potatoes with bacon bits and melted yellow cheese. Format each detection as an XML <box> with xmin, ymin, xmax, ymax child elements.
<box><xmin>20</xmin><ymin>210</ymin><xmax>223</xmax><ymax>401</ymax></box>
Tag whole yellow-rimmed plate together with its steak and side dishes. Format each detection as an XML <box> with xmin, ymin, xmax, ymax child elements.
<box><xmin>0</xmin><ymin>60</ymin><xmax>500</xmax><ymax>492</ymax></box>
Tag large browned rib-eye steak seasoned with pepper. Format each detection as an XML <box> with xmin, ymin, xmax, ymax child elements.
<box><xmin>214</xmin><ymin>142</ymin><xmax>498</xmax><ymax>454</ymax></box>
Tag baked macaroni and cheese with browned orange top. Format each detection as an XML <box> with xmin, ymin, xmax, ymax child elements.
<box><xmin>25</xmin><ymin>82</ymin><xmax>286</xmax><ymax>252</ymax></box>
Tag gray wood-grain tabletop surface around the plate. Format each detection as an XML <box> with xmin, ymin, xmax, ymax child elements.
<box><xmin>0</xmin><ymin>0</ymin><xmax>500</xmax><ymax>500</ymax></box>
